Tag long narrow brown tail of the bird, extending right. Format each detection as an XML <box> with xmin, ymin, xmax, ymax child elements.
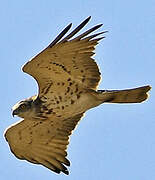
<box><xmin>97</xmin><ymin>86</ymin><xmax>151</xmax><ymax>103</ymax></box>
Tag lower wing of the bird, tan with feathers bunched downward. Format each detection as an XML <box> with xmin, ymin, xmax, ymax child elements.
<box><xmin>5</xmin><ymin>114</ymin><xmax>83</xmax><ymax>174</ymax></box>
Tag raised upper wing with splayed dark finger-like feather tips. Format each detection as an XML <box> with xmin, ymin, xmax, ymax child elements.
<box><xmin>23</xmin><ymin>17</ymin><xmax>104</xmax><ymax>101</ymax></box>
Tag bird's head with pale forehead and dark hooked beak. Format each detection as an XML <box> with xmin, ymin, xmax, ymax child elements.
<box><xmin>12</xmin><ymin>97</ymin><xmax>34</xmax><ymax>118</ymax></box>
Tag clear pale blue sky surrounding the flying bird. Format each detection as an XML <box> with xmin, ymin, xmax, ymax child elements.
<box><xmin>0</xmin><ymin>0</ymin><xmax>155</xmax><ymax>180</ymax></box>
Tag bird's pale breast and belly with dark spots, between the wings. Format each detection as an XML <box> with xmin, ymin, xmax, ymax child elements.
<box><xmin>40</xmin><ymin>90</ymin><xmax>99</xmax><ymax>118</ymax></box>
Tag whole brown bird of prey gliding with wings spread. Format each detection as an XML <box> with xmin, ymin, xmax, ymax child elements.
<box><xmin>5</xmin><ymin>17</ymin><xmax>151</xmax><ymax>175</ymax></box>
